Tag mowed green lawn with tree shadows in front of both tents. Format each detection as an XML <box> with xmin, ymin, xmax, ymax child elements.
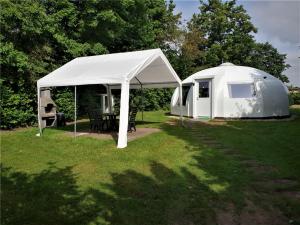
<box><xmin>1</xmin><ymin>109</ymin><xmax>300</xmax><ymax>225</ymax></box>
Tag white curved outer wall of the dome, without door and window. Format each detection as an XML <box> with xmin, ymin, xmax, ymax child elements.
<box><xmin>171</xmin><ymin>66</ymin><xmax>289</xmax><ymax>118</ymax></box>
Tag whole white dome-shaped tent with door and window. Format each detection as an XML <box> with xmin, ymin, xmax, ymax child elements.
<box><xmin>171</xmin><ymin>63</ymin><xmax>289</xmax><ymax>119</ymax></box>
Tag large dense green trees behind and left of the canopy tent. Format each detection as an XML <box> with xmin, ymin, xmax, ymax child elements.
<box><xmin>0</xmin><ymin>0</ymin><xmax>180</xmax><ymax>126</ymax></box>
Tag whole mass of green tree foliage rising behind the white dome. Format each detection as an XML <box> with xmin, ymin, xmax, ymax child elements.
<box><xmin>181</xmin><ymin>0</ymin><xmax>289</xmax><ymax>82</ymax></box>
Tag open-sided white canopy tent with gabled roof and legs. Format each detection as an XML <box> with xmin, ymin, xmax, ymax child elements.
<box><xmin>37</xmin><ymin>49</ymin><xmax>181</xmax><ymax>148</ymax></box>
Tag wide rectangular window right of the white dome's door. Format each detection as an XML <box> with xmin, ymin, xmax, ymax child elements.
<box><xmin>228</xmin><ymin>83</ymin><xmax>256</xmax><ymax>98</ymax></box>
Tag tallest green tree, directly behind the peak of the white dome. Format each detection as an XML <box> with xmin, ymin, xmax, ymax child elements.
<box><xmin>189</xmin><ymin>0</ymin><xmax>257</xmax><ymax>67</ymax></box>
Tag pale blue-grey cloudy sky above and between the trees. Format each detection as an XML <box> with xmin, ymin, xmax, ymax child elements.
<box><xmin>174</xmin><ymin>0</ymin><xmax>300</xmax><ymax>87</ymax></box>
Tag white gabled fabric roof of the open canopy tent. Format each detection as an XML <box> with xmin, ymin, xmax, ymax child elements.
<box><xmin>37</xmin><ymin>49</ymin><xmax>181</xmax><ymax>87</ymax></box>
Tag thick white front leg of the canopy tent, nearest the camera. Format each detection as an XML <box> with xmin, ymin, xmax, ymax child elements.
<box><xmin>117</xmin><ymin>80</ymin><xmax>129</xmax><ymax>148</ymax></box>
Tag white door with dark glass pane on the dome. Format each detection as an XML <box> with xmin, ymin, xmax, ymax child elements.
<box><xmin>195</xmin><ymin>79</ymin><xmax>212</xmax><ymax>118</ymax></box>
